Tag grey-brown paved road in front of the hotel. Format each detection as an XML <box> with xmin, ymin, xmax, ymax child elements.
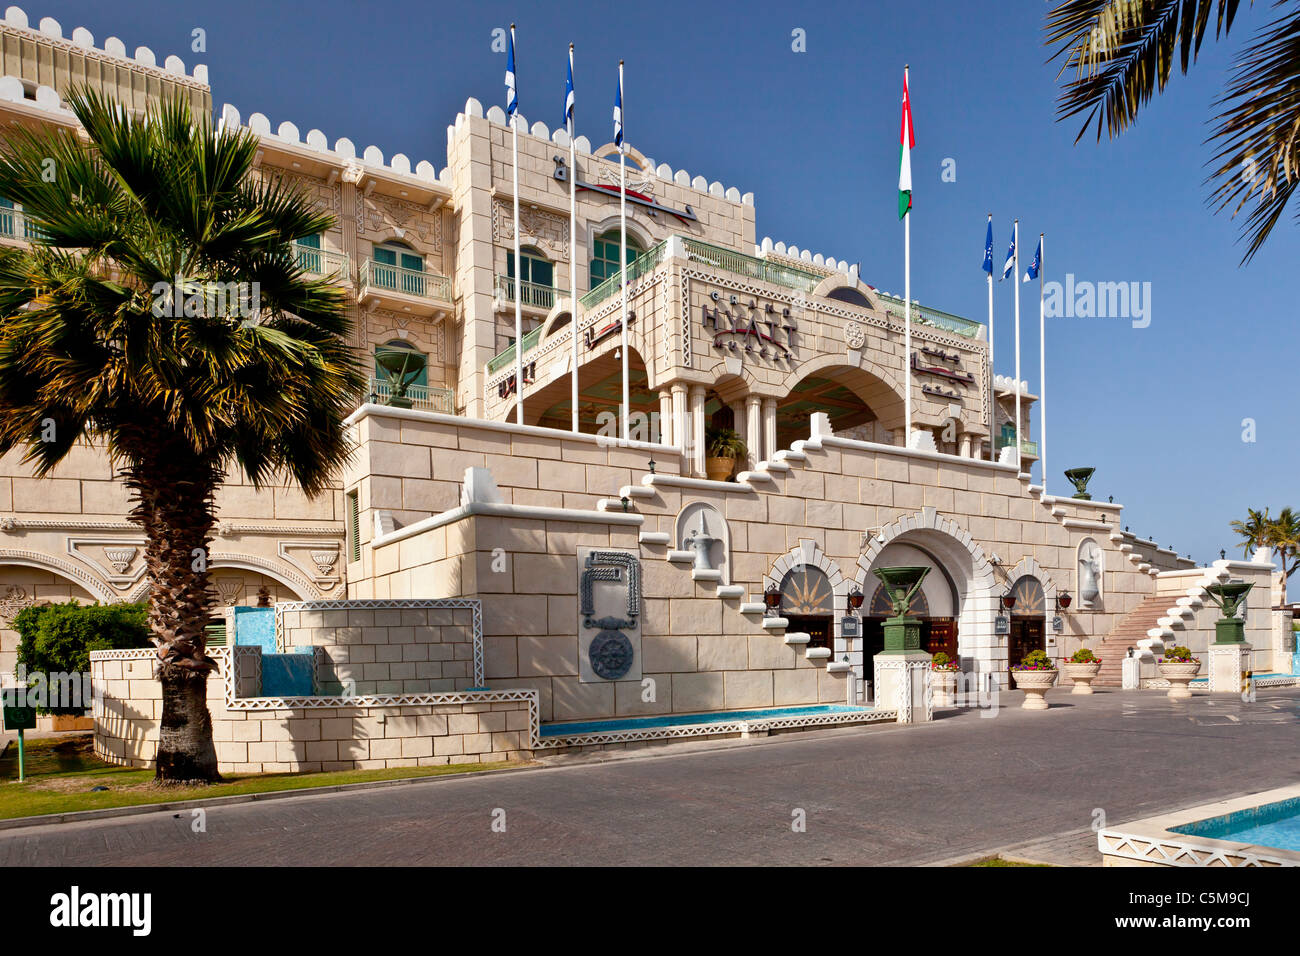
<box><xmin>0</xmin><ymin>689</ymin><xmax>1300</xmax><ymax>866</ymax></box>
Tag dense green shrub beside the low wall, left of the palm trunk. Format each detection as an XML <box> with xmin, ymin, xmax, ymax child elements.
<box><xmin>13</xmin><ymin>601</ymin><xmax>151</xmax><ymax>714</ymax></box>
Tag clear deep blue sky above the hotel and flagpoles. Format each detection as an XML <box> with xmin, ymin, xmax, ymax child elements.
<box><xmin>40</xmin><ymin>0</ymin><xmax>1300</xmax><ymax>562</ymax></box>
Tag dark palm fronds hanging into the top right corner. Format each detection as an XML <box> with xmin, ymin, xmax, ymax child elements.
<box><xmin>1047</xmin><ymin>0</ymin><xmax>1300</xmax><ymax>264</ymax></box>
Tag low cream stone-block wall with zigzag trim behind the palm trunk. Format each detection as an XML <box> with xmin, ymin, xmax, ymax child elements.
<box><xmin>91</xmin><ymin>648</ymin><xmax>537</xmax><ymax>774</ymax></box>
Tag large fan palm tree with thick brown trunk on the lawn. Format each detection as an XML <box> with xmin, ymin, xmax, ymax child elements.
<box><xmin>0</xmin><ymin>91</ymin><xmax>361</xmax><ymax>782</ymax></box>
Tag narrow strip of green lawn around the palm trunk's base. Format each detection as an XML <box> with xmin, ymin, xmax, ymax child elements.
<box><xmin>0</xmin><ymin>734</ymin><xmax>519</xmax><ymax>819</ymax></box>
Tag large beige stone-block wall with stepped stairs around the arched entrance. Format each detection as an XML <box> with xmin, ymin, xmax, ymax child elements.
<box><xmin>345</xmin><ymin>408</ymin><xmax>1180</xmax><ymax>719</ymax></box>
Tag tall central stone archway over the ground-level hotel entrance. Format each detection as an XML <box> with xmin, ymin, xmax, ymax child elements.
<box><xmin>849</xmin><ymin>506</ymin><xmax>1006</xmax><ymax>679</ymax></box>
